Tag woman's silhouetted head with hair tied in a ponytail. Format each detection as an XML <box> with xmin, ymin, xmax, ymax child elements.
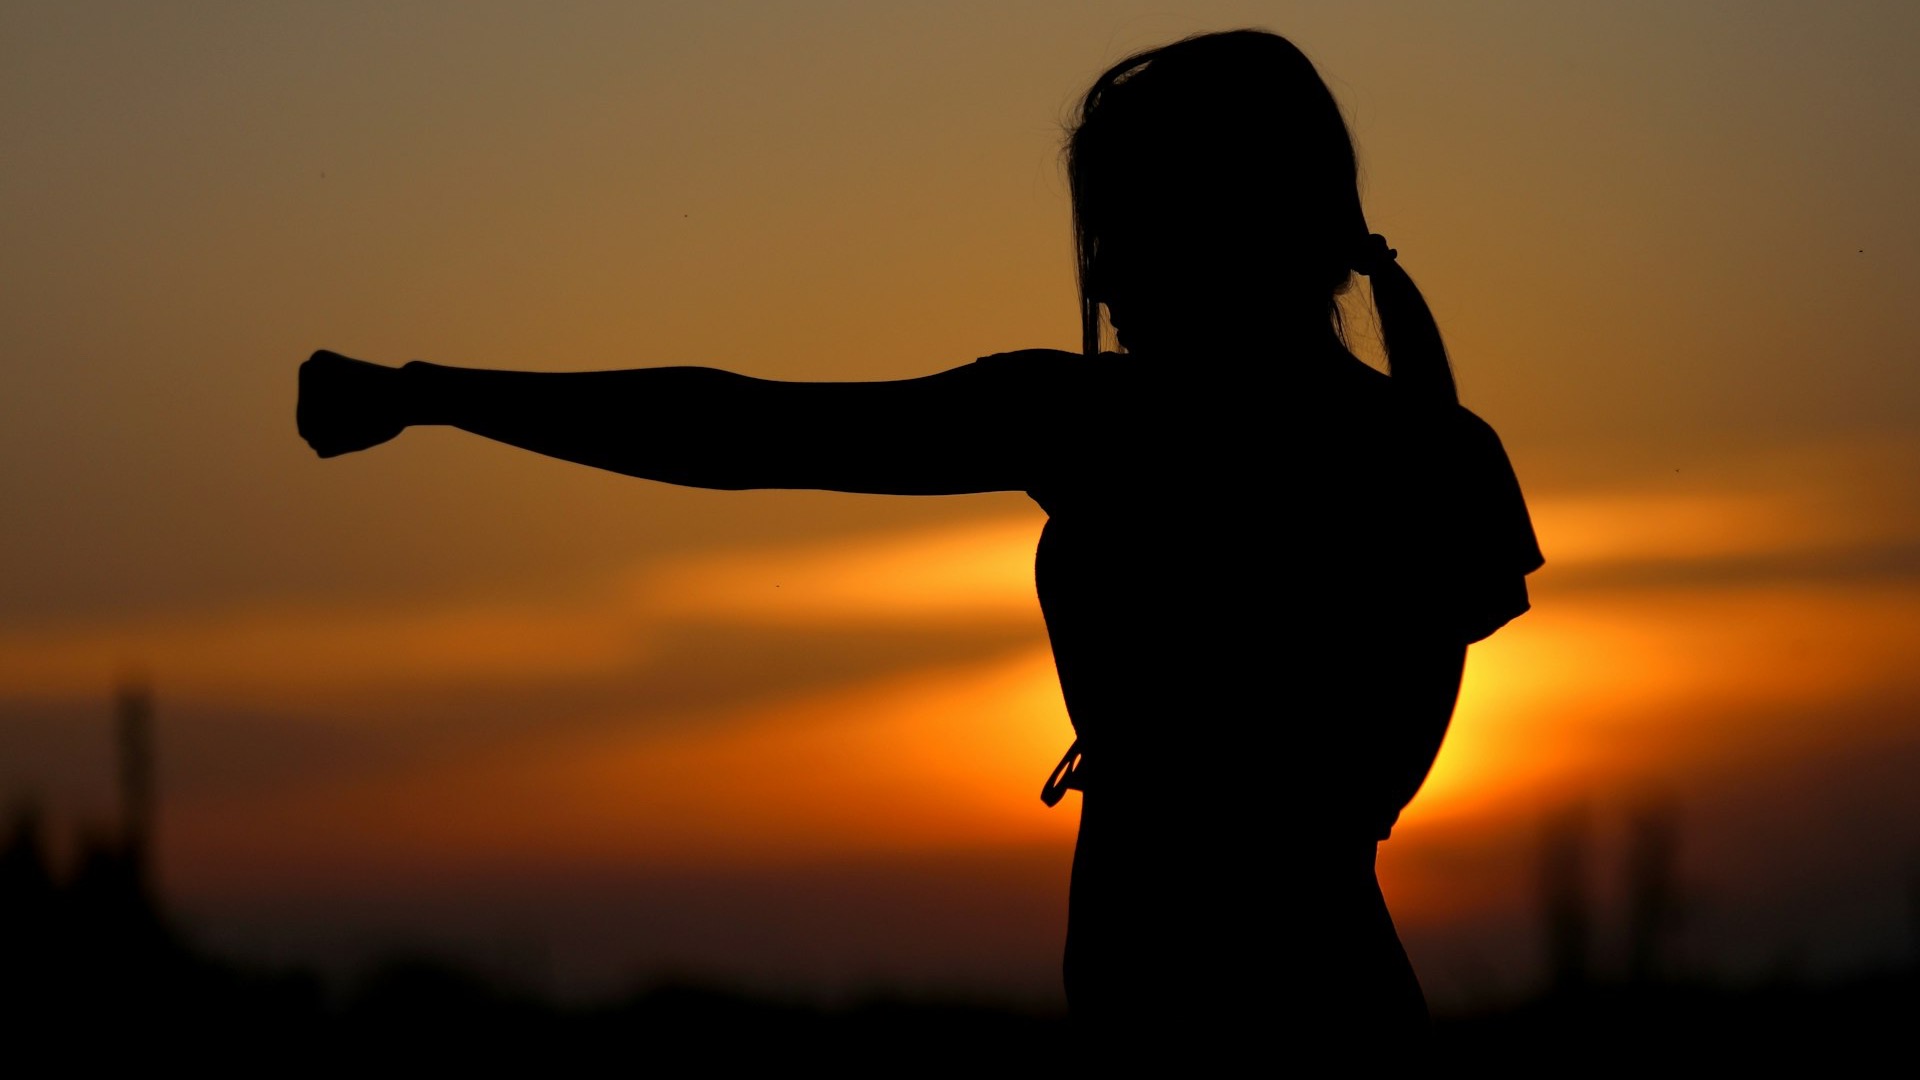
<box><xmin>1066</xmin><ymin>31</ymin><xmax>1455</xmax><ymax>402</ymax></box>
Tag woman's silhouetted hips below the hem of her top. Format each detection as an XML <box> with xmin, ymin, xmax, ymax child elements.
<box><xmin>1066</xmin><ymin>792</ymin><xmax>1427</xmax><ymax>1034</ymax></box>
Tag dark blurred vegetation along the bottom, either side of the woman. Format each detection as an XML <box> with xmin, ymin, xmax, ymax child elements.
<box><xmin>0</xmin><ymin>795</ymin><xmax>1920</xmax><ymax>1072</ymax></box>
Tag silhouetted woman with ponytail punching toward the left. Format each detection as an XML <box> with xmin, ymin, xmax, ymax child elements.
<box><xmin>300</xmin><ymin>31</ymin><xmax>1542</xmax><ymax>1053</ymax></box>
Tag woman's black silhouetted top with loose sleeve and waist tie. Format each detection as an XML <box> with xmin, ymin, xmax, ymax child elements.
<box><xmin>972</xmin><ymin>352</ymin><xmax>1544</xmax><ymax>840</ymax></box>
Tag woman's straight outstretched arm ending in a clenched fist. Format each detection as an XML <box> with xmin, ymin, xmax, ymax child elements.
<box><xmin>300</xmin><ymin>352</ymin><xmax>1067</xmax><ymax>494</ymax></box>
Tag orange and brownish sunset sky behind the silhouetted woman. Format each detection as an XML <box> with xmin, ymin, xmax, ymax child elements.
<box><xmin>0</xmin><ymin>2</ymin><xmax>1920</xmax><ymax>1003</ymax></box>
